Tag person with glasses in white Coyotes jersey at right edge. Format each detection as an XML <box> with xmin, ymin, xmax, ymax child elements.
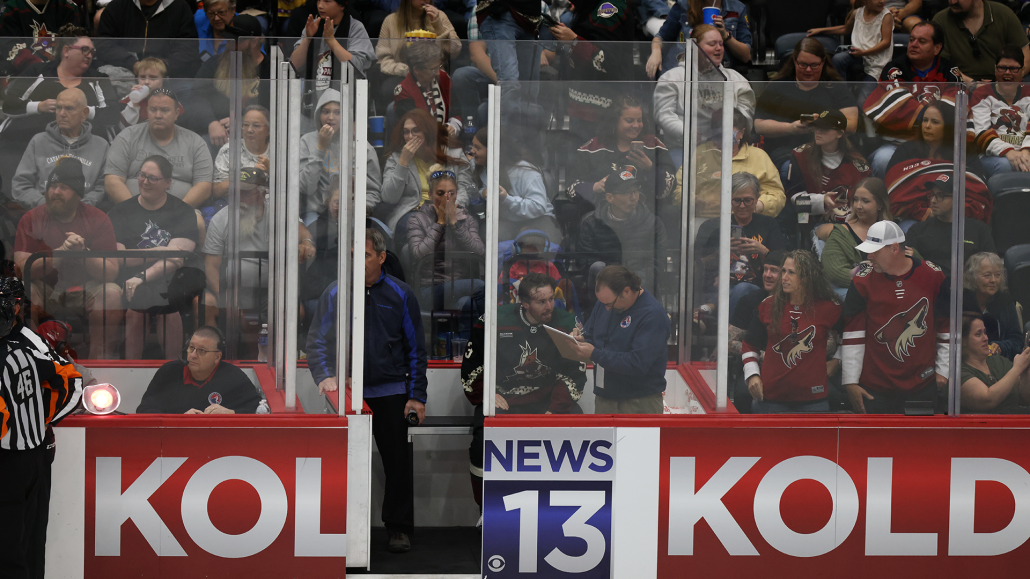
<box><xmin>969</xmin><ymin>44</ymin><xmax>1030</xmax><ymax>173</ymax></box>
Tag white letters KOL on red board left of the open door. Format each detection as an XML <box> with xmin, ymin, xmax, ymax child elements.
<box><xmin>95</xmin><ymin>456</ymin><xmax>347</xmax><ymax>558</ymax></box>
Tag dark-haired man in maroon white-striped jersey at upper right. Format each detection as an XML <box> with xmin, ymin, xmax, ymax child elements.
<box><xmin>862</xmin><ymin>22</ymin><xmax>961</xmax><ymax>178</ymax></box>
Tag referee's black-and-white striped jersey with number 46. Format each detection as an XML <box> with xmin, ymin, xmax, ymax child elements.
<box><xmin>0</xmin><ymin>323</ymin><xmax>82</xmax><ymax>450</ymax></box>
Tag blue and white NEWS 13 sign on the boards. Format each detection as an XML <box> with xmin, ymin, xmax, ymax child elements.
<box><xmin>483</xmin><ymin>429</ymin><xmax>615</xmax><ymax>579</ymax></box>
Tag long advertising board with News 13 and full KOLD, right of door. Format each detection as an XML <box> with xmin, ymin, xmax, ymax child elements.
<box><xmin>483</xmin><ymin>420</ymin><xmax>1030</xmax><ymax>579</ymax></box>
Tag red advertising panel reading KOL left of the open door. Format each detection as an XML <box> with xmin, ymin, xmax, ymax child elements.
<box><xmin>84</xmin><ymin>428</ymin><xmax>347</xmax><ymax>579</ymax></box>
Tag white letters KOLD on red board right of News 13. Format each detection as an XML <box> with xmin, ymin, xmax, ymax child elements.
<box><xmin>668</xmin><ymin>456</ymin><xmax>1030</xmax><ymax>557</ymax></box>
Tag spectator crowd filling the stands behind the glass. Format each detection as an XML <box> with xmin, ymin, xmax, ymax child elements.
<box><xmin>0</xmin><ymin>0</ymin><xmax>1030</xmax><ymax>413</ymax></box>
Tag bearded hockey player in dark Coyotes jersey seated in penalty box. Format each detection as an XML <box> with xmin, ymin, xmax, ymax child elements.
<box><xmin>461</xmin><ymin>273</ymin><xmax>586</xmax><ymax>507</ymax></box>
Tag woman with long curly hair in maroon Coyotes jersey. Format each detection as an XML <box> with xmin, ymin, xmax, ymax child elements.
<box><xmin>743</xmin><ymin>249</ymin><xmax>840</xmax><ymax>413</ymax></box>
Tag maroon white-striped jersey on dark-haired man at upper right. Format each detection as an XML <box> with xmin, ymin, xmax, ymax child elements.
<box><xmin>862</xmin><ymin>55</ymin><xmax>961</xmax><ymax>140</ymax></box>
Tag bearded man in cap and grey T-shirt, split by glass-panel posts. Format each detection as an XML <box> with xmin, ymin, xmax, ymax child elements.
<box><xmin>203</xmin><ymin>167</ymin><xmax>315</xmax><ymax>343</ymax></box>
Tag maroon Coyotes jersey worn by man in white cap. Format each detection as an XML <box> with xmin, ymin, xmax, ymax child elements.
<box><xmin>840</xmin><ymin>259</ymin><xmax>951</xmax><ymax>391</ymax></box>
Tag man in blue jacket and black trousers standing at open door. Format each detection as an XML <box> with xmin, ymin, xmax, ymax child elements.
<box><xmin>305</xmin><ymin>229</ymin><xmax>428</xmax><ymax>553</ymax></box>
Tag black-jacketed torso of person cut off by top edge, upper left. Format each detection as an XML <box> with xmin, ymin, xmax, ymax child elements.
<box><xmin>96</xmin><ymin>0</ymin><xmax>200</xmax><ymax>78</ymax></box>
